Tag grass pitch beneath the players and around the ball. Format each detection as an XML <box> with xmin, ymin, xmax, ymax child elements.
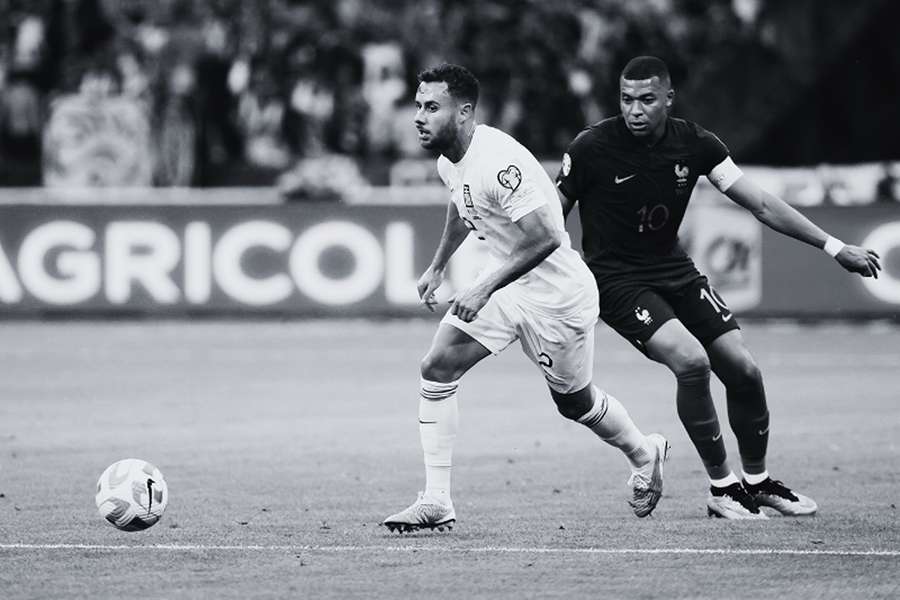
<box><xmin>0</xmin><ymin>320</ymin><xmax>900</xmax><ymax>599</ymax></box>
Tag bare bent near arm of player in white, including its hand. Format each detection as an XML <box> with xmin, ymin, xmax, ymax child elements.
<box><xmin>451</xmin><ymin>206</ymin><xmax>562</xmax><ymax>323</ymax></box>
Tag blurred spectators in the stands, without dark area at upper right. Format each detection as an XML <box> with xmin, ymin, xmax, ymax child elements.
<box><xmin>0</xmin><ymin>0</ymin><xmax>896</xmax><ymax>202</ymax></box>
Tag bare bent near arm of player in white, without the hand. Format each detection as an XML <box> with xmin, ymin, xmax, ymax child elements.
<box><xmin>484</xmin><ymin>206</ymin><xmax>562</xmax><ymax>294</ymax></box>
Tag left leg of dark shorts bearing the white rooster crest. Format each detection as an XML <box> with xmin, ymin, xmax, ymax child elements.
<box><xmin>600</xmin><ymin>286</ymin><xmax>676</xmax><ymax>354</ymax></box>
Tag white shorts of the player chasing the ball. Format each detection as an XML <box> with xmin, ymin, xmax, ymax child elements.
<box><xmin>441</xmin><ymin>280</ymin><xmax>599</xmax><ymax>394</ymax></box>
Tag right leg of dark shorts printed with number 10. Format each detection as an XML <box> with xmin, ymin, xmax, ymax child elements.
<box><xmin>672</xmin><ymin>277</ymin><xmax>740</xmax><ymax>347</ymax></box>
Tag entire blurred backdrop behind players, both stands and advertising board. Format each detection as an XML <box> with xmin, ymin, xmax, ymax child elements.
<box><xmin>0</xmin><ymin>0</ymin><xmax>900</xmax><ymax>318</ymax></box>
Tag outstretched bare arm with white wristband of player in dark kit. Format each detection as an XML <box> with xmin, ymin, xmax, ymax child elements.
<box><xmin>724</xmin><ymin>176</ymin><xmax>881</xmax><ymax>278</ymax></box>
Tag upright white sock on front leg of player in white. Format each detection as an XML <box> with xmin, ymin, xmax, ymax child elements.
<box><xmin>419</xmin><ymin>379</ymin><xmax>459</xmax><ymax>502</ymax></box>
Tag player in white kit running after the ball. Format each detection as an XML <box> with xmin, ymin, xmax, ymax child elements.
<box><xmin>383</xmin><ymin>64</ymin><xmax>668</xmax><ymax>533</ymax></box>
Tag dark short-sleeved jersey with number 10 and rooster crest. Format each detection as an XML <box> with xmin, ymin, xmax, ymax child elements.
<box><xmin>557</xmin><ymin>116</ymin><xmax>728</xmax><ymax>284</ymax></box>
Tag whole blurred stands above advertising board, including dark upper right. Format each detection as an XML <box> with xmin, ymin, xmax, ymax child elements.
<box><xmin>0</xmin><ymin>0</ymin><xmax>900</xmax><ymax>204</ymax></box>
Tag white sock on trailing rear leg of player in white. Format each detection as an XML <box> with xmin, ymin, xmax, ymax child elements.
<box><xmin>578</xmin><ymin>386</ymin><xmax>653</xmax><ymax>468</ymax></box>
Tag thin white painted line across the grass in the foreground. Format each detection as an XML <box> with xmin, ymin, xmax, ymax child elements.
<box><xmin>0</xmin><ymin>544</ymin><xmax>900</xmax><ymax>558</ymax></box>
